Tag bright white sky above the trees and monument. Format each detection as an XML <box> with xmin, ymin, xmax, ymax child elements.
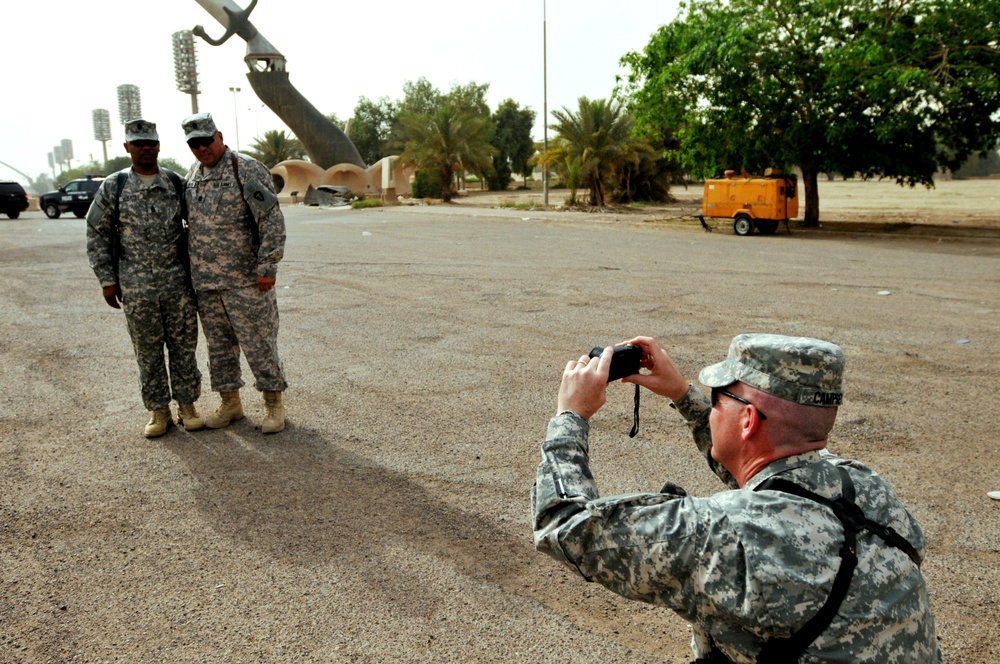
<box><xmin>0</xmin><ymin>0</ymin><xmax>678</xmax><ymax>182</ymax></box>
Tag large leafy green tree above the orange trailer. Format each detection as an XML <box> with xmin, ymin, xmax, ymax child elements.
<box><xmin>622</xmin><ymin>0</ymin><xmax>1000</xmax><ymax>225</ymax></box>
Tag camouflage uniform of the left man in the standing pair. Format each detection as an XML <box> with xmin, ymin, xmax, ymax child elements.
<box><xmin>87</xmin><ymin>169</ymin><xmax>201</xmax><ymax>411</ymax></box>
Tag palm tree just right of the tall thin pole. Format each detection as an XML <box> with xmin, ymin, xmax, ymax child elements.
<box><xmin>543</xmin><ymin>97</ymin><xmax>638</xmax><ymax>206</ymax></box>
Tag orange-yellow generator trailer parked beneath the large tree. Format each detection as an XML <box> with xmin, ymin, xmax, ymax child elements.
<box><xmin>698</xmin><ymin>169</ymin><xmax>799</xmax><ymax>235</ymax></box>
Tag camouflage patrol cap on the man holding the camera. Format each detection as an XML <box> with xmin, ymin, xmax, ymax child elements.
<box><xmin>698</xmin><ymin>334</ymin><xmax>844</xmax><ymax>408</ymax></box>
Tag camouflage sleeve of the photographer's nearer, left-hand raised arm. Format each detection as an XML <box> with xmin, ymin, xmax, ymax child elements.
<box><xmin>531</xmin><ymin>414</ymin><xmax>704</xmax><ymax>611</ymax></box>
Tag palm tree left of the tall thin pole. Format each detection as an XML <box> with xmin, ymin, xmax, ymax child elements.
<box><xmin>399</xmin><ymin>104</ymin><xmax>496</xmax><ymax>202</ymax></box>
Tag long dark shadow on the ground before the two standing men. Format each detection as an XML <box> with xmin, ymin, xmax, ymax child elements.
<box><xmin>164</xmin><ymin>420</ymin><xmax>540</xmax><ymax>612</ymax></box>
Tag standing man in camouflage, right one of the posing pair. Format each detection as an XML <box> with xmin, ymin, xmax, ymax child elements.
<box><xmin>181</xmin><ymin>113</ymin><xmax>288</xmax><ymax>433</ymax></box>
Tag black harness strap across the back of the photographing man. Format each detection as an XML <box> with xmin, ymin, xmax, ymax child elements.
<box><xmin>754</xmin><ymin>466</ymin><xmax>921</xmax><ymax>664</ymax></box>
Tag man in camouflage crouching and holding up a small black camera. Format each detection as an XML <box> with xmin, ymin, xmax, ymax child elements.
<box><xmin>531</xmin><ymin>334</ymin><xmax>941</xmax><ymax>662</ymax></box>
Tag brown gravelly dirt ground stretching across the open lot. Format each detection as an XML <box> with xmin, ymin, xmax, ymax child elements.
<box><xmin>0</xmin><ymin>182</ymin><xmax>1000</xmax><ymax>663</ymax></box>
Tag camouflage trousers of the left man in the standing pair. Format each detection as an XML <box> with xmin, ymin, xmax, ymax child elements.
<box><xmin>122</xmin><ymin>291</ymin><xmax>201</xmax><ymax>410</ymax></box>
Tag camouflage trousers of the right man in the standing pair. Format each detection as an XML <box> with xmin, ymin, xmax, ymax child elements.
<box><xmin>198</xmin><ymin>286</ymin><xmax>288</xmax><ymax>392</ymax></box>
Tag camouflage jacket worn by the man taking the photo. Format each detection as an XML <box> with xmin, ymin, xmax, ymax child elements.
<box><xmin>531</xmin><ymin>338</ymin><xmax>941</xmax><ymax>662</ymax></box>
